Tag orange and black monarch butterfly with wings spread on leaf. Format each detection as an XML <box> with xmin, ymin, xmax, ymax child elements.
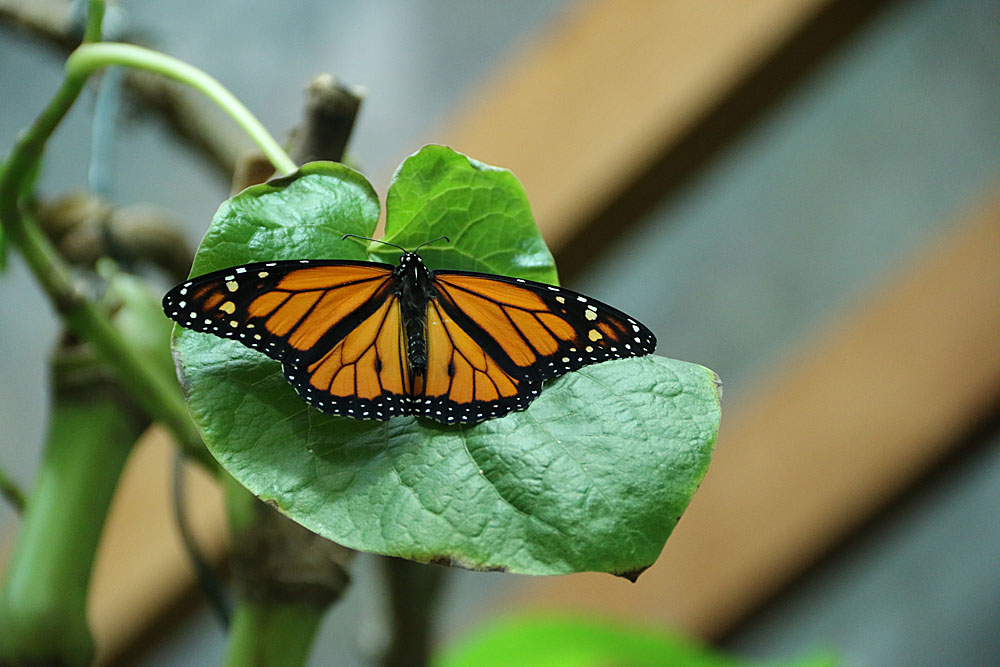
<box><xmin>163</xmin><ymin>234</ymin><xmax>656</xmax><ymax>424</ymax></box>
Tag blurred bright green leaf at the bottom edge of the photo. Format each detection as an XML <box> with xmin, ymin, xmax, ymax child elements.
<box><xmin>432</xmin><ymin>614</ymin><xmax>838</xmax><ymax>667</ymax></box>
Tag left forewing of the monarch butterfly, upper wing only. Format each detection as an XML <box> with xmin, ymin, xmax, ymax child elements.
<box><xmin>163</xmin><ymin>260</ymin><xmax>393</xmax><ymax>365</ymax></box>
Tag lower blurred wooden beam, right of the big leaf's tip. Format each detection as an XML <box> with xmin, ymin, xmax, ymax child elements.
<box><xmin>517</xmin><ymin>184</ymin><xmax>1000</xmax><ymax>638</ymax></box>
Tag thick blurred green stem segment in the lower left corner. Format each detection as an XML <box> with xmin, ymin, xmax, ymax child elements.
<box><xmin>0</xmin><ymin>396</ymin><xmax>141</xmax><ymax>665</ymax></box>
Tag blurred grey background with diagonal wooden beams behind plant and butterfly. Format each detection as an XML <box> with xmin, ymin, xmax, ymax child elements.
<box><xmin>0</xmin><ymin>0</ymin><xmax>1000</xmax><ymax>666</ymax></box>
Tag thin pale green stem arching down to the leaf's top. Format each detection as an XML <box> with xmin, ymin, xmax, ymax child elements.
<box><xmin>66</xmin><ymin>42</ymin><xmax>297</xmax><ymax>174</ymax></box>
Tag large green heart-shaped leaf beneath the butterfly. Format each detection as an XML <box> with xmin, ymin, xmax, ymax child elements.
<box><xmin>174</xmin><ymin>146</ymin><xmax>719</xmax><ymax>576</ymax></box>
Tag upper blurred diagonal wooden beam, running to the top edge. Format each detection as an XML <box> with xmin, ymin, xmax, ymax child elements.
<box><xmin>442</xmin><ymin>0</ymin><xmax>886</xmax><ymax>273</ymax></box>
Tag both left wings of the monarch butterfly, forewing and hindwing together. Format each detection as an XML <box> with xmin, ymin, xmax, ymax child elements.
<box><xmin>163</xmin><ymin>260</ymin><xmax>422</xmax><ymax>419</ymax></box>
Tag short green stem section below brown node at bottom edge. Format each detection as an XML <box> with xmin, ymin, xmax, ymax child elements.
<box><xmin>226</xmin><ymin>599</ymin><xmax>325</xmax><ymax>667</ymax></box>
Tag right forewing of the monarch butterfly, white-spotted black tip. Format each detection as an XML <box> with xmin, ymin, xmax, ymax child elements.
<box><xmin>434</xmin><ymin>271</ymin><xmax>656</xmax><ymax>383</ymax></box>
